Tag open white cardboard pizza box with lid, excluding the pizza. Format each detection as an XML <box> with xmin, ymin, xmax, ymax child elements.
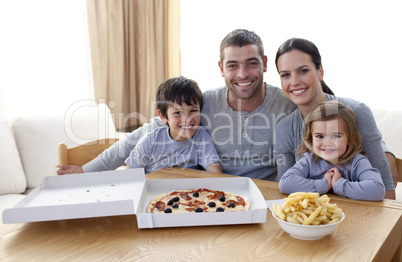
<box><xmin>3</xmin><ymin>169</ymin><xmax>267</xmax><ymax>228</ymax></box>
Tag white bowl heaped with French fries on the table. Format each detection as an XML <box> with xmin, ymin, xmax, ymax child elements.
<box><xmin>272</xmin><ymin>192</ymin><xmax>345</xmax><ymax>240</ymax></box>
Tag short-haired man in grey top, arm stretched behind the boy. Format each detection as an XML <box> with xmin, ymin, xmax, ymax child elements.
<box><xmin>57</xmin><ymin>29</ymin><xmax>296</xmax><ymax>180</ymax></box>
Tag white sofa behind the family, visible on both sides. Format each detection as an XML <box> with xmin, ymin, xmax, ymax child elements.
<box><xmin>0</xmin><ymin>103</ymin><xmax>402</xmax><ymax>223</ymax></box>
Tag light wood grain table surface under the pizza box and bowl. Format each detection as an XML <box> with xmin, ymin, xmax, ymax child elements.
<box><xmin>0</xmin><ymin>168</ymin><xmax>402</xmax><ymax>261</ymax></box>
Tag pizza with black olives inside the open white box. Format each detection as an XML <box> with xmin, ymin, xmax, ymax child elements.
<box><xmin>147</xmin><ymin>188</ymin><xmax>250</xmax><ymax>213</ymax></box>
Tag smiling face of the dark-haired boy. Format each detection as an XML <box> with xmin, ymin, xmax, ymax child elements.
<box><xmin>158</xmin><ymin>102</ymin><xmax>201</xmax><ymax>141</ymax></box>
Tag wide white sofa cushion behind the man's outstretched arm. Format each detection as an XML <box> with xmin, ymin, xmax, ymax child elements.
<box><xmin>11</xmin><ymin>103</ymin><xmax>116</xmax><ymax>188</ymax></box>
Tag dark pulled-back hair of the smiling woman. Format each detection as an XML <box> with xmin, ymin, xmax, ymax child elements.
<box><xmin>275</xmin><ymin>38</ymin><xmax>335</xmax><ymax>95</ymax></box>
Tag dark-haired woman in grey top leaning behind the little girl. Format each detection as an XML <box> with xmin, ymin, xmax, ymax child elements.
<box><xmin>274</xmin><ymin>38</ymin><xmax>395</xmax><ymax>199</ymax></box>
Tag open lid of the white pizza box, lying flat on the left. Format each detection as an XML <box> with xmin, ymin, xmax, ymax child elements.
<box><xmin>3</xmin><ymin>169</ymin><xmax>145</xmax><ymax>224</ymax></box>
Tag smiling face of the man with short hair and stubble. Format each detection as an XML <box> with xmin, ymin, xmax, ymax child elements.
<box><xmin>219</xmin><ymin>45</ymin><xmax>267</xmax><ymax>99</ymax></box>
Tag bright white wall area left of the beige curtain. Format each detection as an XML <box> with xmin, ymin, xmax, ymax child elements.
<box><xmin>0</xmin><ymin>0</ymin><xmax>93</xmax><ymax>117</ymax></box>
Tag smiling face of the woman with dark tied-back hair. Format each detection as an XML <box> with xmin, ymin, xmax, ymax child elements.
<box><xmin>277</xmin><ymin>49</ymin><xmax>325</xmax><ymax>107</ymax></box>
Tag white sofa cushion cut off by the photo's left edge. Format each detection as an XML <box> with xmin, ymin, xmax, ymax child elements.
<box><xmin>0</xmin><ymin>119</ymin><xmax>27</xmax><ymax>195</ymax></box>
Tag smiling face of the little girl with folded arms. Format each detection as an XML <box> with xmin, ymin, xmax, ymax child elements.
<box><xmin>311</xmin><ymin>119</ymin><xmax>348</xmax><ymax>165</ymax></box>
